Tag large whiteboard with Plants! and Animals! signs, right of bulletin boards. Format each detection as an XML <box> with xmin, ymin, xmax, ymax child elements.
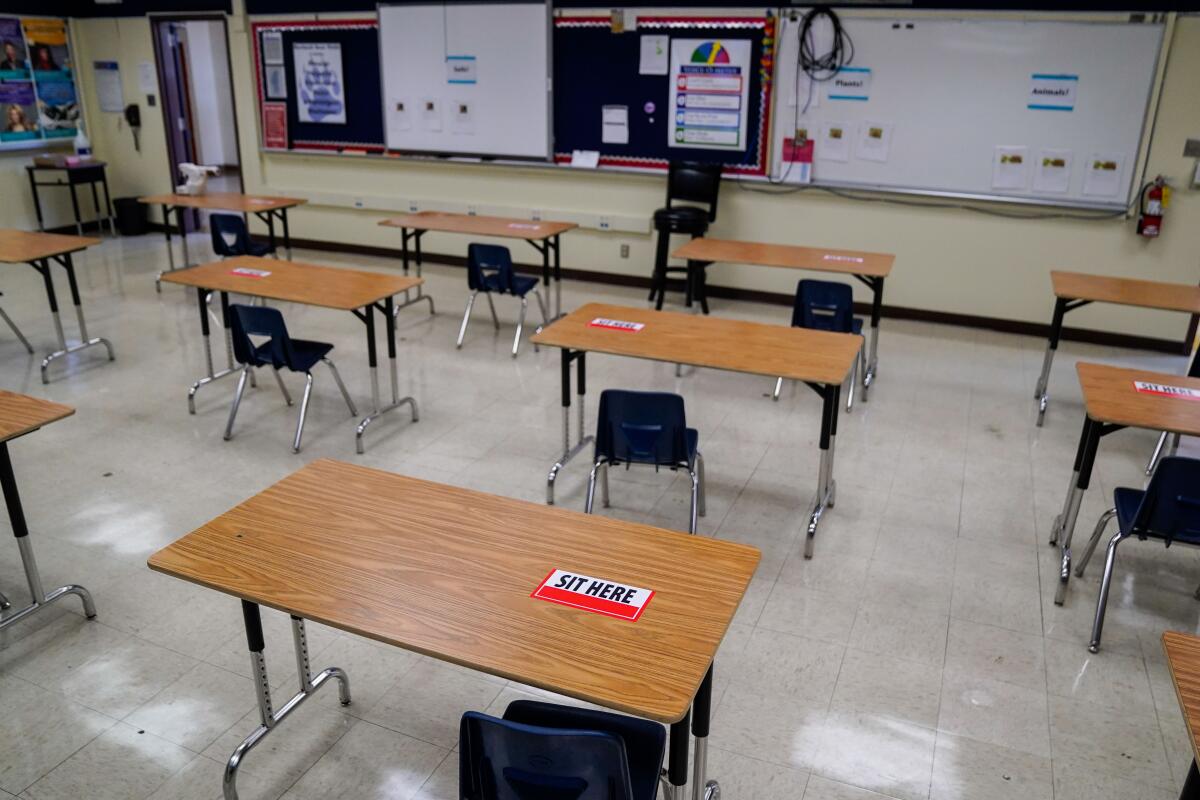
<box><xmin>772</xmin><ymin>14</ymin><xmax>1163</xmax><ymax>209</ymax></box>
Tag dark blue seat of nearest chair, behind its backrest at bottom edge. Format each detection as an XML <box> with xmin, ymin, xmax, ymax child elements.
<box><xmin>504</xmin><ymin>700</ymin><xmax>667</xmax><ymax>800</ymax></box>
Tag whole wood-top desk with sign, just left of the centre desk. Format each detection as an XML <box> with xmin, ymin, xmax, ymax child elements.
<box><xmin>162</xmin><ymin>255</ymin><xmax>422</xmax><ymax>453</ymax></box>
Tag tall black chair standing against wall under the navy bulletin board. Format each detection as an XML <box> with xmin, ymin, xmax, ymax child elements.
<box><xmin>650</xmin><ymin>161</ymin><xmax>721</xmax><ymax>314</ymax></box>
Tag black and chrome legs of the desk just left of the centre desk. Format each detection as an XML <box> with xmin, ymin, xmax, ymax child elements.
<box><xmin>187</xmin><ymin>288</ymin><xmax>420</xmax><ymax>455</ymax></box>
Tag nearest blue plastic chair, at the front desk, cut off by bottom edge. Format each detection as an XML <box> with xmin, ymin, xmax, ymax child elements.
<box><xmin>458</xmin><ymin>700</ymin><xmax>666</xmax><ymax>800</ymax></box>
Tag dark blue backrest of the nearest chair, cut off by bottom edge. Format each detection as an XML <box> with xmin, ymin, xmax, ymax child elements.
<box><xmin>458</xmin><ymin>711</ymin><xmax>634</xmax><ymax>800</ymax></box>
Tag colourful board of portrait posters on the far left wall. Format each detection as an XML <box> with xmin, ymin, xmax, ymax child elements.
<box><xmin>0</xmin><ymin>17</ymin><xmax>80</xmax><ymax>150</ymax></box>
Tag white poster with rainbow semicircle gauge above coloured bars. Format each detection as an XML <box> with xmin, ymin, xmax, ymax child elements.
<box><xmin>667</xmin><ymin>38</ymin><xmax>751</xmax><ymax>150</ymax></box>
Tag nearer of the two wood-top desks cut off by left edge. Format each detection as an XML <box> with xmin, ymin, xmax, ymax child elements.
<box><xmin>0</xmin><ymin>390</ymin><xmax>96</xmax><ymax>631</ymax></box>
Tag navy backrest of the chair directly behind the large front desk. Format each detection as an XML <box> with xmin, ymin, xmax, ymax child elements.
<box><xmin>595</xmin><ymin>389</ymin><xmax>689</xmax><ymax>467</ymax></box>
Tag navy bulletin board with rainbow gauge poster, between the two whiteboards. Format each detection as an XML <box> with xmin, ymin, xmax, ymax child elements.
<box><xmin>554</xmin><ymin>16</ymin><xmax>775</xmax><ymax>175</ymax></box>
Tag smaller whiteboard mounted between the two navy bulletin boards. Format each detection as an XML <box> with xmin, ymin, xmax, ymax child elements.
<box><xmin>379</xmin><ymin>2</ymin><xmax>551</xmax><ymax>158</ymax></box>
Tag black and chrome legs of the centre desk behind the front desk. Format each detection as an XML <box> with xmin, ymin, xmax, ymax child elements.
<box><xmin>546</xmin><ymin>348</ymin><xmax>841</xmax><ymax>559</ymax></box>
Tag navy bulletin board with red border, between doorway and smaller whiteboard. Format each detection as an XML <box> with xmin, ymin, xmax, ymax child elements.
<box><xmin>251</xmin><ymin>19</ymin><xmax>385</xmax><ymax>154</ymax></box>
